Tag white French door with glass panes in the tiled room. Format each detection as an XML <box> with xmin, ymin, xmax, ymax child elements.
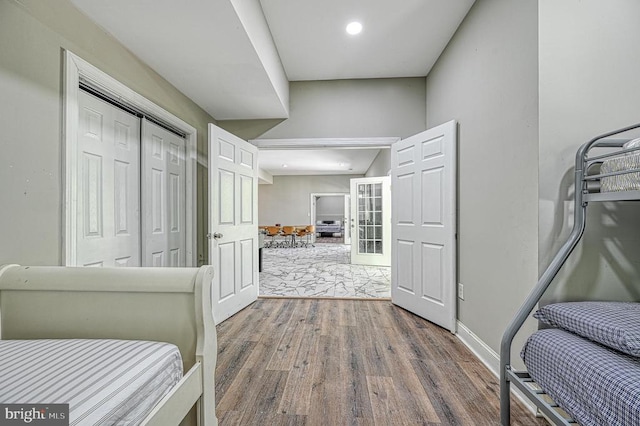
<box><xmin>350</xmin><ymin>176</ymin><xmax>391</xmax><ymax>266</ymax></box>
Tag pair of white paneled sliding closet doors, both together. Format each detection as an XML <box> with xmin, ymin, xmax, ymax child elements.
<box><xmin>74</xmin><ymin>90</ymin><xmax>187</xmax><ymax>266</ymax></box>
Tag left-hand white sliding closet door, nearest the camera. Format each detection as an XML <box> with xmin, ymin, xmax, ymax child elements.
<box><xmin>76</xmin><ymin>91</ymin><xmax>140</xmax><ymax>266</ymax></box>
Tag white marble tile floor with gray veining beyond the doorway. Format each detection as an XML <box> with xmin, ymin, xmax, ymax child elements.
<box><xmin>259</xmin><ymin>244</ymin><xmax>391</xmax><ymax>298</ymax></box>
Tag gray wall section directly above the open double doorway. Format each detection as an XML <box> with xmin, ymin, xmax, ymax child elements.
<box><xmin>254</xmin><ymin>78</ymin><xmax>426</xmax><ymax>139</ymax></box>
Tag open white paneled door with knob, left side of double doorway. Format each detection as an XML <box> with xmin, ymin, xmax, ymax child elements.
<box><xmin>208</xmin><ymin>124</ymin><xmax>258</xmax><ymax>324</ymax></box>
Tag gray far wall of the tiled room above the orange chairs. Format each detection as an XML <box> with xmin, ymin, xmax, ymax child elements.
<box><xmin>258</xmin><ymin>175</ymin><xmax>362</xmax><ymax>225</ymax></box>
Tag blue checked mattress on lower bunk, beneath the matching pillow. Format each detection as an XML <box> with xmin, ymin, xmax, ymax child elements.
<box><xmin>521</xmin><ymin>328</ymin><xmax>640</xmax><ymax>426</ymax></box>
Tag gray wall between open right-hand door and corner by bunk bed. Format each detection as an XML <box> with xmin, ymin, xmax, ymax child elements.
<box><xmin>427</xmin><ymin>0</ymin><xmax>538</xmax><ymax>352</ymax></box>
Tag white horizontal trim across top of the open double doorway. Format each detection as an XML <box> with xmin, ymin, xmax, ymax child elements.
<box><xmin>249</xmin><ymin>137</ymin><xmax>400</xmax><ymax>149</ymax></box>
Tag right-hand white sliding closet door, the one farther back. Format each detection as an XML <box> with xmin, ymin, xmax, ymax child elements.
<box><xmin>142</xmin><ymin>119</ymin><xmax>186</xmax><ymax>266</ymax></box>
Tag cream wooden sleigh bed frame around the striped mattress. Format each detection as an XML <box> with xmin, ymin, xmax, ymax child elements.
<box><xmin>0</xmin><ymin>265</ymin><xmax>218</xmax><ymax>426</ymax></box>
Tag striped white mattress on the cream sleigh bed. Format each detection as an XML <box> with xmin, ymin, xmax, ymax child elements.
<box><xmin>0</xmin><ymin>339</ymin><xmax>182</xmax><ymax>426</ymax></box>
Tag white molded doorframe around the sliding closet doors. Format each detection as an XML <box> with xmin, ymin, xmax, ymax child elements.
<box><xmin>61</xmin><ymin>49</ymin><xmax>198</xmax><ymax>267</ymax></box>
